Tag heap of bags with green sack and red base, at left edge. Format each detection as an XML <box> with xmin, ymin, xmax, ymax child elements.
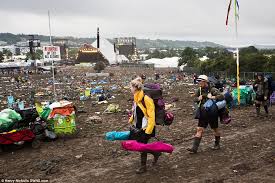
<box><xmin>0</xmin><ymin>108</ymin><xmax>56</xmax><ymax>148</ymax></box>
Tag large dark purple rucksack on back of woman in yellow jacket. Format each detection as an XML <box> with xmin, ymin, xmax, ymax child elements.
<box><xmin>142</xmin><ymin>84</ymin><xmax>174</xmax><ymax>126</ymax></box>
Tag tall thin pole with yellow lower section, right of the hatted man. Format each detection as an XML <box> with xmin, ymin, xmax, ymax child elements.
<box><xmin>234</xmin><ymin>0</ymin><xmax>241</xmax><ymax>105</ymax></box>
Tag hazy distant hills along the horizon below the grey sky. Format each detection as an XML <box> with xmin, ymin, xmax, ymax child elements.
<box><xmin>0</xmin><ymin>33</ymin><xmax>223</xmax><ymax>49</ymax></box>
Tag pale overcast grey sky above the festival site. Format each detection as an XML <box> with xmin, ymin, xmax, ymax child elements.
<box><xmin>0</xmin><ymin>0</ymin><xmax>275</xmax><ymax>45</ymax></box>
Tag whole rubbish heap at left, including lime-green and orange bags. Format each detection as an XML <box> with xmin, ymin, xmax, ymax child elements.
<box><xmin>0</xmin><ymin>101</ymin><xmax>76</xmax><ymax>151</ymax></box>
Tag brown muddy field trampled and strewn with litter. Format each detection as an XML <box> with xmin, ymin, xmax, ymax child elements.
<box><xmin>0</xmin><ymin>68</ymin><xmax>275</xmax><ymax>183</ymax></box>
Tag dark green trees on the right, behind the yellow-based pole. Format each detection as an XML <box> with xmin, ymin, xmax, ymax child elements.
<box><xmin>179</xmin><ymin>46</ymin><xmax>275</xmax><ymax>74</ymax></box>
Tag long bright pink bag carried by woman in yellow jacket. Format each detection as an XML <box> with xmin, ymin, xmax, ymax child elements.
<box><xmin>121</xmin><ymin>140</ymin><xmax>174</xmax><ymax>153</ymax></box>
